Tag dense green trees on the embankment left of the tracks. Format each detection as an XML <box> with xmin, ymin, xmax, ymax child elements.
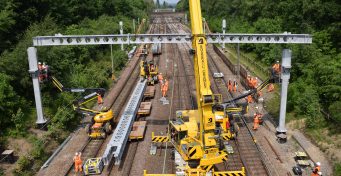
<box><xmin>0</xmin><ymin>0</ymin><xmax>150</xmax><ymax>175</ymax></box>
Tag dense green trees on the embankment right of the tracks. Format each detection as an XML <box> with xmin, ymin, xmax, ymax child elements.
<box><xmin>177</xmin><ymin>0</ymin><xmax>341</xmax><ymax>128</ymax></box>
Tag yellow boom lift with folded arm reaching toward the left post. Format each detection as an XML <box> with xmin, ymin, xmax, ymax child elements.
<box><xmin>50</xmin><ymin>76</ymin><xmax>114</xmax><ymax>138</ymax></box>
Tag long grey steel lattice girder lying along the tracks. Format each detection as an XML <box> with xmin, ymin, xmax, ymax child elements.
<box><xmin>102</xmin><ymin>80</ymin><xmax>147</xmax><ymax>165</ymax></box>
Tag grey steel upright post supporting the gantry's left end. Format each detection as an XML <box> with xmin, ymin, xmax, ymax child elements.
<box><xmin>27</xmin><ymin>47</ymin><xmax>46</xmax><ymax>126</ymax></box>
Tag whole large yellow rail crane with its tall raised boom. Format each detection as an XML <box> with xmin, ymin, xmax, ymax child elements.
<box><xmin>146</xmin><ymin>0</ymin><xmax>245</xmax><ymax>175</ymax></box>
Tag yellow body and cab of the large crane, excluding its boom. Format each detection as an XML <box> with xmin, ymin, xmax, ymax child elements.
<box><xmin>169</xmin><ymin>109</ymin><xmax>233</xmax><ymax>168</ymax></box>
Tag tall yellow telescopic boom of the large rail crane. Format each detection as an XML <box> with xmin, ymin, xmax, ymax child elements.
<box><xmin>189</xmin><ymin>0</ymin><xmax>216</xmax><ymax>148</ymax></box>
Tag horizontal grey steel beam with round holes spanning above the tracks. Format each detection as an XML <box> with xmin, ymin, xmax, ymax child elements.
<box><xmin>33</xmin><ymin>33</ymin><xmax>312</xmax><ymax>46</ymax></box>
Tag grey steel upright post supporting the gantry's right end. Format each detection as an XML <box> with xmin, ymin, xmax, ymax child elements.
<box><xmin>276</xmin><ymin>49</ymin><xmax>291</xmax><ymax>141</ymax></box>
